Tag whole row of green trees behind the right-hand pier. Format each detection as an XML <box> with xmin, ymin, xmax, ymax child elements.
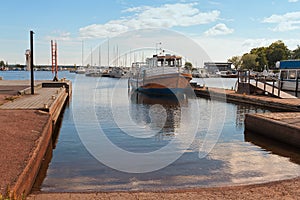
<box><xmin>228</xmin><ymin>40</ymin><xmax>300</xmax><ymax>71</ymax></box>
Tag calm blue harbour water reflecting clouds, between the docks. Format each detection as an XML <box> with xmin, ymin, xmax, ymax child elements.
<box><xmin>0</xmin><ymin>72</ymin><xmax>300</xmax><ymax>192</ymax></box>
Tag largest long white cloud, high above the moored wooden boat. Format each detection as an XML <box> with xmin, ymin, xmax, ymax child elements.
<box><xmin>79</xmin><ymin>3</ymin><xmax>220</xmax><ymax>38</ymax></box>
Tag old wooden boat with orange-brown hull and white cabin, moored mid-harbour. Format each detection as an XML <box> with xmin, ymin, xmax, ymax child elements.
<box><xmin>128</xmin><ymin>54</ymin><xmax>192</xmax><ymax>95</ymax></box>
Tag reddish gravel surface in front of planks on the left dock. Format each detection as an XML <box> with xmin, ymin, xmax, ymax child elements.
<box><xmin>0</xmin><ymin>110</ymin><xmax>49</xmax><ymax>194</ymax></box>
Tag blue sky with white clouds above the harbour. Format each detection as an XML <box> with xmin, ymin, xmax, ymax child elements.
<box><xmin>0</xmin><ymin>0</ymin><xmax>300</xmax><ymax>65</ymax></box>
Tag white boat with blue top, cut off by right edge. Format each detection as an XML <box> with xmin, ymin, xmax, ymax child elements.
<box><xmin>279</xmin><ymin>60</ymin><xmax>300</xmax><ymax>92</ymax></box>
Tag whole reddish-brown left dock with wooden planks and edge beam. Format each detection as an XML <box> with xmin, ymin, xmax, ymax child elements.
<box><xmin>0</xmin><ymin>80</ymin><xmax>72</xmax><ymax>199</ymax></box>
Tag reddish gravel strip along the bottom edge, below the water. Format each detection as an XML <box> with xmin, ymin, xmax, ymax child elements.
<box><xmin>27</xmin><ymin>177</ymin><xmax>300</xmax><ymax>200</ymax></box>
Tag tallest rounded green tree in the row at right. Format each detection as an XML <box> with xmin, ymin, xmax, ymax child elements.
<box><xmin>266</xmin><ymin>40</ymin><xmax>290</xmax><ymax>68</ymax></box>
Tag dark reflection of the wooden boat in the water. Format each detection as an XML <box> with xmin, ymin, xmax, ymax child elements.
<box><xmin>129</xmin><ymin>91</ymin><xmax>188</xmax><ymax>137</ymax></box>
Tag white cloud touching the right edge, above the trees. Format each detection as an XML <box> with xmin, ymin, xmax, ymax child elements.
<box><xmin>262</xmin><ymin>12</ymin><xmax>300</xmax><ymax>32</ymax></box>
